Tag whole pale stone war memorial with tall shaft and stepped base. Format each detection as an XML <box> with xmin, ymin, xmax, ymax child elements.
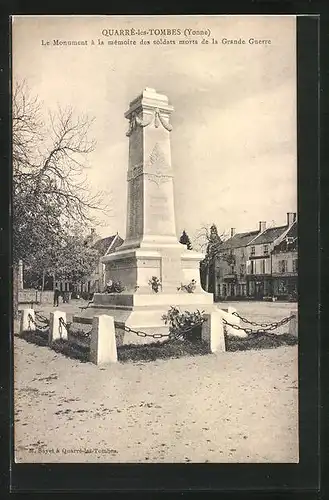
<box><xmin>77</xmin><ymin>88</ymin><xmax>214</xmax><ymax>343</ymax></box>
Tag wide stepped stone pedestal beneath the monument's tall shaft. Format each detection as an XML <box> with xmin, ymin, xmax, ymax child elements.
<box><xmin>75</xmin><ymin>243</ymin><xmax>216</xmax><ymax>345</ymax></box>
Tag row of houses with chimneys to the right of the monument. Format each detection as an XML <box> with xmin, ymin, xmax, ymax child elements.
<box><xmin>216</xmin><ymin>212</ymin><xmax>297</xmax><ymax>300</ymax></box>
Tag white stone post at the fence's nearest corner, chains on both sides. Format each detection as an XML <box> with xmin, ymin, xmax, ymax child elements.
<box><xmin>90</xmin><ymin>314</ymin><xmax>118</xmax><ymax>365</ymax></box>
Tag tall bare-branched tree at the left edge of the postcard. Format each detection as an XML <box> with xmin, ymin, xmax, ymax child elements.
<box><xmin>12</xmin><ymin>82</ymin><xmax>109</xmax><ymax>314</ymax></box>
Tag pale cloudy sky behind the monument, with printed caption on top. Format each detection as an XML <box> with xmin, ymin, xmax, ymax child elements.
<box><xmin>12</xmin><ymin>16</ymin><xmax>297</xmax><ymax>244</ymax></box>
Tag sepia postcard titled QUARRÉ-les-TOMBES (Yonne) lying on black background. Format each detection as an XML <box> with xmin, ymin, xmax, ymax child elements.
<box><xmin>12</xmin><ymin>15</ymin><xmax>299</xmax><ymax>464</ymax></box>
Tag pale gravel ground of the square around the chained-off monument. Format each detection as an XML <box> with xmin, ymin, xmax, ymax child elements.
<box><xmin>14</xmin><ymin>302</ymin><xmax>298</xmax><ymax>463</ymax></box>
